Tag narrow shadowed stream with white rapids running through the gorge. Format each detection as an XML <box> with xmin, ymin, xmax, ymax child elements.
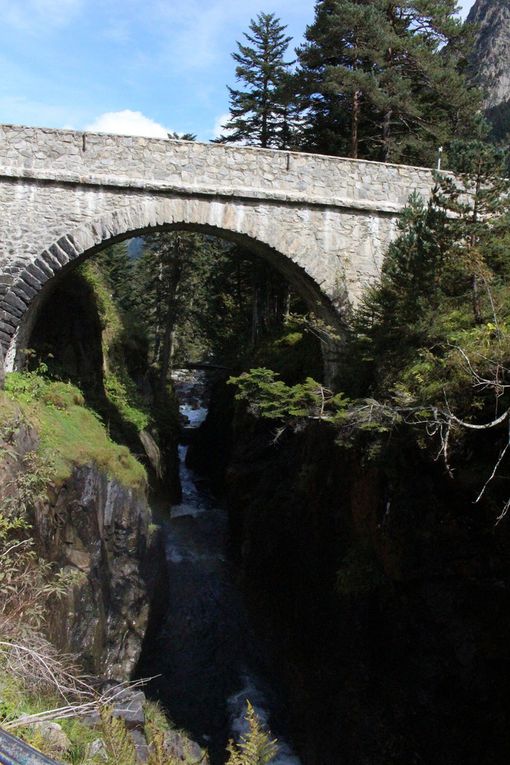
<box><xmin>137</xmin><ymin>375</ymin><xmax>300</xmax><ymax>765</ymax></box>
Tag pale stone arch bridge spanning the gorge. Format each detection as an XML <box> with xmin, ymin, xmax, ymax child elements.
<box><xmin>0</xmin><ymin>125</ymin><xmax>433</xmax><ymax>368</ymax></box>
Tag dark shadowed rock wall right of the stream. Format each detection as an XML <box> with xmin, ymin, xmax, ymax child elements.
<box><xmin>190</xmin><ymin>394</ymin><xmax>510</xmax><ymax>765</ymax></box>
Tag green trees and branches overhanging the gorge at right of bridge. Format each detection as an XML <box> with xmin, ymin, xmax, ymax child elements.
<box><xmin>232</xmin><ymin>141</ymin><xmax>510</xmax><ymax>517</ymax></box>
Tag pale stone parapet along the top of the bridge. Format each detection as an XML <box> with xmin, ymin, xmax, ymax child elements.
<box><xmin>0</xmin><ymin>125</ymin><xmax>432</xmax><ymax>214</ymax></box>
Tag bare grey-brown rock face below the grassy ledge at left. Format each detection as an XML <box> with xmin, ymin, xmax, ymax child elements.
<box><xmin>0</xmin><ymin>424</ymin><xmax>165</xmax><ymax>680</ymax></box>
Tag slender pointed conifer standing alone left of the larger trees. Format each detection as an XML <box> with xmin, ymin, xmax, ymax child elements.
<box><xmin>219</xmin><ymin>13</ymin><xmax>295</xmax><ymax>148</ymax></box>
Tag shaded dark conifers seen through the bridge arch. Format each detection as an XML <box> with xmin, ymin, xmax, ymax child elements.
<box><xmin>100</xmin><ymin>231</ymin><xmax>310</xmax><ymax>381</ymax></box>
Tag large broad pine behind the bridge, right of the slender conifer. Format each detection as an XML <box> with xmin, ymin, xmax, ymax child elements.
<box><xmin>297</xmin><ymin>0</ymin><xmax>478</xmax><ymax>164</ymax></box>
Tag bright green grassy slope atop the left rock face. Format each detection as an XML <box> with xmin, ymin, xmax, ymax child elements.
<box><xmin>0</xmin><ymin>372</ymin><xmax>146</xmax><ymax>488</ymax></box>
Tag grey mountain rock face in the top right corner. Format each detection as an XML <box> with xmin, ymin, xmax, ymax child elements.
<box><xmin>467</xmin><ymin>0</ymin><xmax>510</xmax><ymax>109</ymax></box>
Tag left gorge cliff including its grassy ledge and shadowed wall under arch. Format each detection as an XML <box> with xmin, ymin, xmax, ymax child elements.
<box><xmin>0</xmin><ymin>264</ymin><xmax>175</xmax><ymax>680</ymax></box>
